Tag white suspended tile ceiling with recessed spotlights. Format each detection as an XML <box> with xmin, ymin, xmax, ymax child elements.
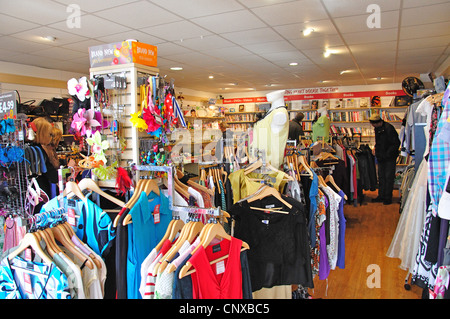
<box><xmin>0</xmin><ymin>0</ymin><xmax>450</xmax><ymax>94</ymax></box>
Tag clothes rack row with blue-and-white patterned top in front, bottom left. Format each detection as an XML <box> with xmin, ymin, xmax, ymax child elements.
<box><xmin>0</xmin><ymin>209</ymin><xmax>106</xmax><ymax>299</ymax></box>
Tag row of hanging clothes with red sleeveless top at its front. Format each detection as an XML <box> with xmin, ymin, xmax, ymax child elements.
<box><xmin>139</xmin><ymin>209</ymin><xmax>251</xmax><ymax>299</ymax></box>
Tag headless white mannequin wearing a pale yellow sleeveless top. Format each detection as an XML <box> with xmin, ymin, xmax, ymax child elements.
<box><xmin>252</xmin><ymin>90</ymin><xmax>289</xmax><ymax>168</ymax></box>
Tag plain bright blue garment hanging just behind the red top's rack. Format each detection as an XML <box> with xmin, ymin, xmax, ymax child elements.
<box><xmin>127</xmin><ymin>192</ymin><xmax>172</xmax><ymax>299</ymax></box>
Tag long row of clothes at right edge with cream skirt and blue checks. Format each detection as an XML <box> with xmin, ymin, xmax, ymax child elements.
<box><xmin>387</xmin><ymin>87</ymin><xmax>450</xmax><ymax>298</ymax></box>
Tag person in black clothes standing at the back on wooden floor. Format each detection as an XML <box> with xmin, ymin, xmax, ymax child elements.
<box><xmin>369</xmin><ymin>114</ymin><xmax>400</xmax><ymax>205</ymax></box>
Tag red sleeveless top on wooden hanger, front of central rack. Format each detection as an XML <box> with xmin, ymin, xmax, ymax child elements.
<box><xmin>189</xmin><ymin>237</ymin><xmax>242</xmax><ymax>299</ymax></box>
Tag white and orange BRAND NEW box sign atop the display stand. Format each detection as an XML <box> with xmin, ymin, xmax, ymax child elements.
<box><xmin>89</xmin><ymin>40</ymin><xmax>158</xmax><ymax>68</ymax></box>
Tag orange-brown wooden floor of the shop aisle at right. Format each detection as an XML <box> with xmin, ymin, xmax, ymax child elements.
<box><xmin>309</xmin><ymin>192</ymin><xmax>422</xmax><ymax>299</ymax></box>
